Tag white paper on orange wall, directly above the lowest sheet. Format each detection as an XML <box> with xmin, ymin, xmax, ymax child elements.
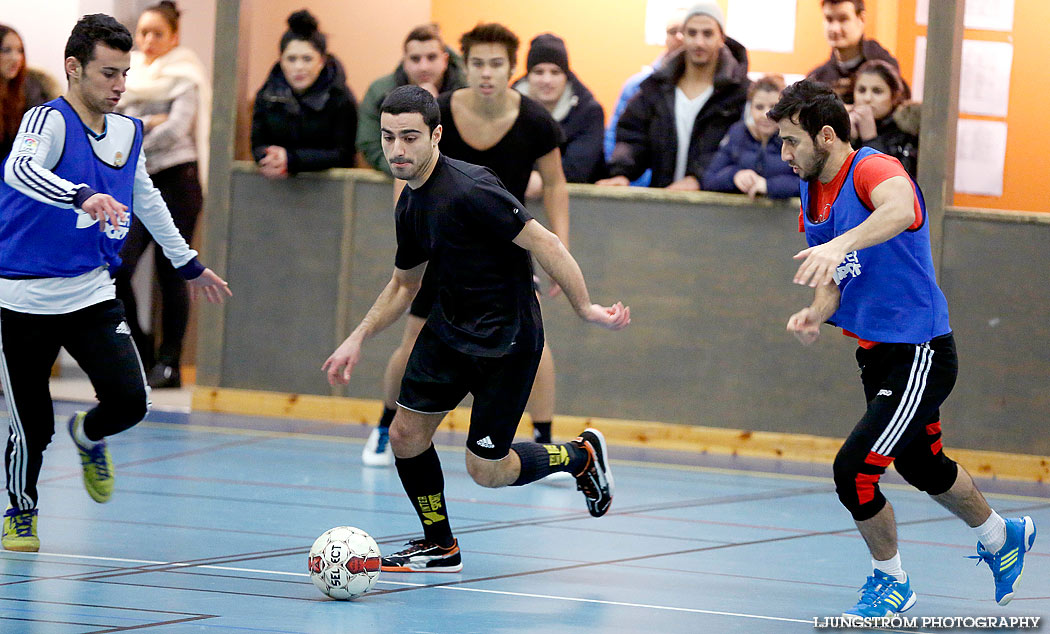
<box><xmin>959</xmin><ymin>40</ymin><xmax>1013</xmax><ymax>117</ymax></box>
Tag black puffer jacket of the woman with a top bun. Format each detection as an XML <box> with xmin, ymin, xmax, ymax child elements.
<box><xmin>252</xmin><ymin>56</ymin><xmax>357</xmax><ymax>174</ymax></box>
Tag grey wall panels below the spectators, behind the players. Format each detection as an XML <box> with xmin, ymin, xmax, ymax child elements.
<box><xmin>219</xmin><ymin>166</ymin><xmax>1050</xmax><ymax>455</ymax></box>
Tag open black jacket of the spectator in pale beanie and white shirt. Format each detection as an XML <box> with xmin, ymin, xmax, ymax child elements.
<box><xmin>609</xmin><ymin>38</ymin><xmax>751</xmax><ymax>187</ymax></box>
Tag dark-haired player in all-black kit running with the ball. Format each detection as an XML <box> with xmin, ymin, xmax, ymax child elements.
<box><xmin>323</xmin><ymin>86</ymin><xmax>630</xmax><ymax>572</ymax></box>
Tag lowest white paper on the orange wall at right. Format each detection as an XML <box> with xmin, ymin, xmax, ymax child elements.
<box><xmin>956</xmin><ymin>119</ymin><xmax>1007</xmax><ymax>196</ymax></box>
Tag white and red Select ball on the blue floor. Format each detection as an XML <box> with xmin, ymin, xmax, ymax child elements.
<box><xmin>309</xmin><ymin>526</ymin><xmax>381</xmax><ymax>599</ymax></box>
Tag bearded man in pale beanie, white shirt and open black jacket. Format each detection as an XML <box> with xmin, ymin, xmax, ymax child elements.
<box><xmin>597</xmin><ymin>1</ymin><xmax>751</xmax><ymax>190</ymax></box>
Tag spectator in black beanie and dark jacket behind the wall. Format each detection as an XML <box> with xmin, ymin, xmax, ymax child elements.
<box><xmin>513</xmin><ymin>33</ymin><xmax>605</xmax><ymax>187</ymax></box>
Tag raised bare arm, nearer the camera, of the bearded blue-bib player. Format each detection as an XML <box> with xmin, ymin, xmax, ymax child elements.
<box><xmin>794</xmin><ymin>176</ymin><xmax>916</xmax><ymax>288</ymax></box>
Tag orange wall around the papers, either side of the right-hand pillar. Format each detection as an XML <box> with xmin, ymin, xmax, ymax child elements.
<box><xmin>897</xmin><ymin>0</ymin><xmax>1050</xmax><ymax>211</ymax></box>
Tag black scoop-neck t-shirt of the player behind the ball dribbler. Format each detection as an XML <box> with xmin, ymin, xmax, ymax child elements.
<box><xmin>438</xmin><ymin>91</ymin><xmax>564</xmax><ymax>200</ymax></box>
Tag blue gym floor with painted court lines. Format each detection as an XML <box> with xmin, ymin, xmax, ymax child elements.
<box><xmin>0</xmin><ymin>403</ymin><xmax>1050</xmax><ymax>634</ymax></box>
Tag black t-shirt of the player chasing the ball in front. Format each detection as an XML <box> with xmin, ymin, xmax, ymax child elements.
<box><xmin>394</xmin><ymin>155</ymin><xmax>543</xmax><ymax>357</ymax></box>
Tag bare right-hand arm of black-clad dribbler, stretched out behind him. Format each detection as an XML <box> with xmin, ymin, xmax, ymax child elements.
<box><xmin>515</xmin><ymin>219</ymin><xmax>631</xmax><ymax>331</ymax></box>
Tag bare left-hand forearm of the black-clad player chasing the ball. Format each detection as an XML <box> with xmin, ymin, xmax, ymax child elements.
<box><xmin>321</xmin><ymin>262</ymin><xmax>426</xmax><ymax>385</ymax></box>
